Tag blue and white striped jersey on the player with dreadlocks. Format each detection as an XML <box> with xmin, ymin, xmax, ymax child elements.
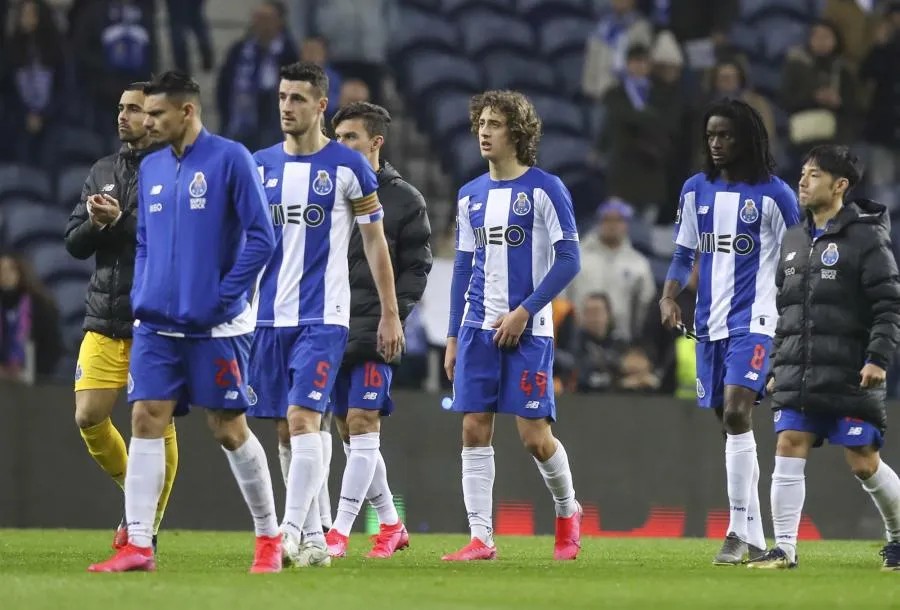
<box><xmin>675</xmin><ymin>173</ymin><xmax>800</xmax><ymax>341</ymax></box>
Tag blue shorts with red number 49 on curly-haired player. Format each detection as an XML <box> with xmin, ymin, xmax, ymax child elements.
<box><xmin>452</xmin><ymin>326</ymin><xmax>556</xmax><ymax>421</ymax></box>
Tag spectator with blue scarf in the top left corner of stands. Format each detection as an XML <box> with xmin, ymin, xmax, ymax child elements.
<box><xmin>3</xmin><ymin>0</ymin><xmax>65</xmax><ymax>165</ymax></box>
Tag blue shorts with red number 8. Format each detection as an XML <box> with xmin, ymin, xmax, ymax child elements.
<box><xmin>697</xmin><ymin>333</ymin><xmax>772</xmax><ymax>409</ymax></box>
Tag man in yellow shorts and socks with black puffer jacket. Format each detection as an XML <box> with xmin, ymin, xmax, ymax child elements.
<box><xmin>66</xmin><ymin>82</ymin><xmax>178</xmax><ymax>553</ymax></box>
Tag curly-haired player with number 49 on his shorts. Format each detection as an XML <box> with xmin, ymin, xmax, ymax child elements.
<box><xmin>444</xmin><ymin>91</ymin><xmax>582</xmax><ymax>561</ymax></box>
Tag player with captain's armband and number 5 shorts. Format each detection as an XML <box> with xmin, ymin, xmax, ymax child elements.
<box><xmin>244</xmin><ymin>62</ymin><xmax>403</xmax><ymax>567</ymax></box>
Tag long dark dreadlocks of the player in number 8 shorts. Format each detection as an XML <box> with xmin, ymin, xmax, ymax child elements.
<box><xmin>702</xmin><ymin>98</ymin><xmax>775</xmax><ymax>184</ymax></box>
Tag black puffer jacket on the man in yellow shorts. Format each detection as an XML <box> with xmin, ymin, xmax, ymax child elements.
<box><xmin>66</xmin><ymin>146</ymin><xmax>159</xmax><ymax>339</ymax></box>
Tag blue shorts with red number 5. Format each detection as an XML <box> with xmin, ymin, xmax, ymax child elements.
<box><xmin>247</xmin><ymin>324</ymin><xmax>347</xmax><ymax>419</ymax></box>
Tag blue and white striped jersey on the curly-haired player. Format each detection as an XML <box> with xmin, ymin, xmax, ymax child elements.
<box><xmin>456</xmin><ymin>167</ymin><xmax>578</xmax><ymax>337</ymax></box>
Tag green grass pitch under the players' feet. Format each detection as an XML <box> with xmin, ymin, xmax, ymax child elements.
<box><xmin>0</xmin><ymin>530</ymin><xmax>900</xmax><ymax>610</ymax></box>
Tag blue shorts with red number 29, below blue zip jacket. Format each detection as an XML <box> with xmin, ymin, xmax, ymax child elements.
<box><xmin>128</xmin><ymin>326</ymin><xmax>250</xmax><ymax>415</ymax></box>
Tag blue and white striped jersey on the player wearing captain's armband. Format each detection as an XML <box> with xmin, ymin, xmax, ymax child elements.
<box><xmin>253</xmin><ymin>141</ymin><xmax>384</xmax><ymax>326</ymax></box>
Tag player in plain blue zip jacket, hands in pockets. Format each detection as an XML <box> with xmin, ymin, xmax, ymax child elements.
<box><xmin>89</xmin><ymin>72</ymin><xmax>281</xmax><ymax>572</ymax></box>
